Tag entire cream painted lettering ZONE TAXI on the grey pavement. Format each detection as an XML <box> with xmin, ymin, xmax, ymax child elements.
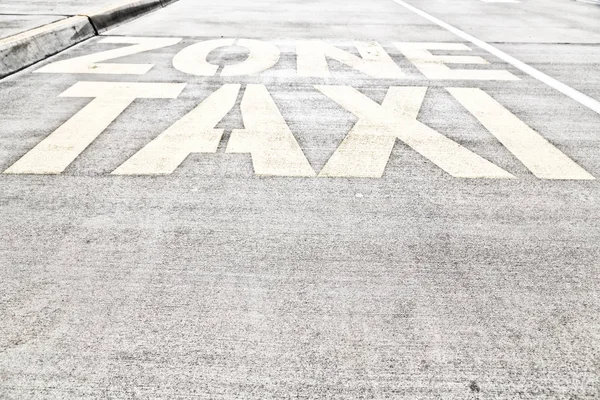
<box><xmin>4</xmin><ymin>37</ymin><xmax>594</xmax><ymax>179</ymax></box>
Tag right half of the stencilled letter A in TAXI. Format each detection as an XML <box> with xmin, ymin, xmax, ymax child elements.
<box><xmin>227</xmin><ymin>85</ymin><xmax>315</xmax><ymax>176</ymax></box>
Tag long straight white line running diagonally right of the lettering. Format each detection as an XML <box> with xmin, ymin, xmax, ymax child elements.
<box><xmin>392</xmin><ymin>0</ymin><xmax>600</xmax><ymax>114</ymax></box>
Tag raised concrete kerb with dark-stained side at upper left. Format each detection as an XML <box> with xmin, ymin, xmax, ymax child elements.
<box><xmin>0</xmin><ymin>0</ymin><xmax>178</xmax><ymax>79</ymax></box>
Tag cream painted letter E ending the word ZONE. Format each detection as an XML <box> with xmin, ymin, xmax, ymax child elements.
<box><xmin>394</xmin><ymin>42</ymin><xmax>519</xmax><ymax>81</ymax></box>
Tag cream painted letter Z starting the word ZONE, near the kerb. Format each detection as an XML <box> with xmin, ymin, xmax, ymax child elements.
<box><xmin>34</xmin><ymin>36</ymin><xmax>181</xmax><ymax>75</ymax></box>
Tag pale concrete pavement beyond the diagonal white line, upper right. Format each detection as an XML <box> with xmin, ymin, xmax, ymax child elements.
<box><xmin>411</xmin><ymin>0</ymin><xmax>600</xmax><ymax>99</ymax></box>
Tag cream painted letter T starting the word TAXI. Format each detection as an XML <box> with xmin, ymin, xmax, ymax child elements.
<box><xmin>4</xmin><ymin>82</ymin><xmax>186</xmax><ymax>174</ymax></box>
